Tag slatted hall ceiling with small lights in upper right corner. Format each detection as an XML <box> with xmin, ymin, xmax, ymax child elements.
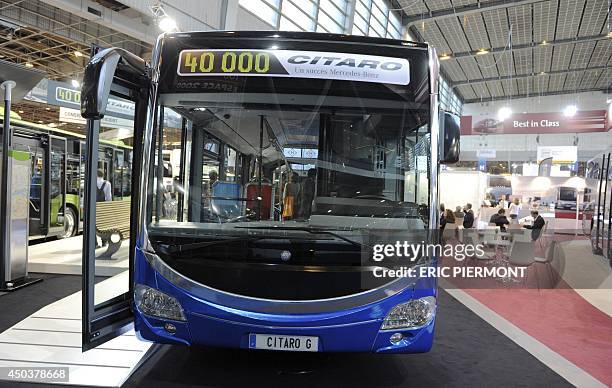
<box><xmin>398</xmin><ymin>0</ymin><xmax>612</xmax><ymax>102</ymax></box>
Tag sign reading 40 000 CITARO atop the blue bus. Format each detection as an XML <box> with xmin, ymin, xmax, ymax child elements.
<box><xmin>176</xmin><ymin>49</ymin><xmax>410</xmax><ymax>85</ymax></box>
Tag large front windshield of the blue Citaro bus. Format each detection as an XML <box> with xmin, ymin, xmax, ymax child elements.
<box><xmin>147</xmin><ymin>39</ymin><xmax>432</xmax><ymax>299</ymax></box>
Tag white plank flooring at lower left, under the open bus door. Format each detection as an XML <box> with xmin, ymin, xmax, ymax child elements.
<box><xmin>0</xmin><ymin>272</ymin><xmax>151</xmax><ymax>387</ymax></box>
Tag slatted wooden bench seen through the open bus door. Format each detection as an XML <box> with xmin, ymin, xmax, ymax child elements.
<box><xmin>96</xmin><ymin>200</ymin><xmax>132</xmax><ymax>259</ymax></box>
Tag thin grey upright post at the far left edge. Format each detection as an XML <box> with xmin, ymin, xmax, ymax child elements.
<box><xmin>0</xmin><ymin>81</ymin><xmax>16</xmax><ymax>289</ymax></box>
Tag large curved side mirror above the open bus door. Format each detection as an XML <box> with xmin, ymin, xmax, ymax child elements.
<box><xmin>81</xmin><ymin>47</ymin><xmax>146</xmax><ymax>120</ymax></box>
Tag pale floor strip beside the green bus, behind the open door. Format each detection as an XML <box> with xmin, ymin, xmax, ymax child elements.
<box><xmin>28</xmin><ymin>236</ymin><xmax>130</xmax><ymax>276</ymax></box>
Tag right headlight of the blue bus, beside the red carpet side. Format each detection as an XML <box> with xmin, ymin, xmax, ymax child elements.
<box><xmin>381</xmin><ymin>296</ymin><xmax>436</xmax><ymax>330</ymax></box>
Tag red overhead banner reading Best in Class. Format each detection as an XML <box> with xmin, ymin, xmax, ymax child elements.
<box><xmin>461</xmin><ymin>110</ymin><xmax>606</xmax><ymax>135</ymax></box>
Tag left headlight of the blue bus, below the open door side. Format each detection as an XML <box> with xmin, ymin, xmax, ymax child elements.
<box><xmin>134</xmin><ymin>284</ymin><xmax>186</xmax><ymax>321</ymax></box>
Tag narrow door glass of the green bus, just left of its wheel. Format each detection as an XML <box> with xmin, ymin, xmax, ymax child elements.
<box><xmin>46</xmin><ymin>135</ymin><xmax>66</xmax><ymax>234</ymax></box>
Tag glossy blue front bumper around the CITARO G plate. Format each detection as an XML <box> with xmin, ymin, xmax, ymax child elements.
<box><xmin>134</xmin><ymin>249</ymin><xmax>437</xmax><ymax>353</ymax></box>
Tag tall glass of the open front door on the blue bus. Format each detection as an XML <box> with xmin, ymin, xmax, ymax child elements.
<box><xmin>83</xmin><ymin>70</ymin><xmax>146</xmax><ymax>350</ymax></box>
